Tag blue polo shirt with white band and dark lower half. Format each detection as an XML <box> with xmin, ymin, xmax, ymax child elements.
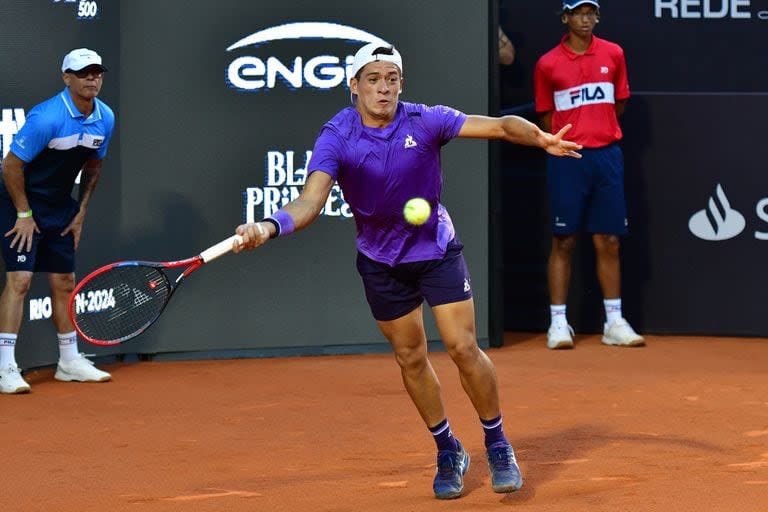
<box><xmin>0</xmin><ymin>88</ymin><xmax>115</xmax><ymax>211</ymax></box>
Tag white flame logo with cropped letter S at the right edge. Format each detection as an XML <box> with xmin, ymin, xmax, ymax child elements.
<box><xmin>688</xmin><ymin>183</ymin><xmax>768</xmax><ymax>242</ymax></box>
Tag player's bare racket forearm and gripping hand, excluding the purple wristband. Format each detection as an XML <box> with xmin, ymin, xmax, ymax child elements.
<box><xmin>232</xmin><ymin>171</ymin><xmax>333</xmax><ymax>252</ymax></box>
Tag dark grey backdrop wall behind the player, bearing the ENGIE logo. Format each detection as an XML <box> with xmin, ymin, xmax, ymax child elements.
<box><xmin>0</xmin><ymin>0</ymin><xmax>489</xmax><ymax>367</ymax></box>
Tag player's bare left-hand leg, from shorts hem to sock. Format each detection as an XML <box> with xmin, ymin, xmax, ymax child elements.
<box><xmin>377</xmin><ymin>306</ymin><xmax>445</xmax><ymax>427</ymax></box>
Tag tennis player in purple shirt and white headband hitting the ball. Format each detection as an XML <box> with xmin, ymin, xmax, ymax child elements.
<box><xmin>234</xmin><ymin>44</ymin><xmax>581</xmax><ymax>499</ymax></box>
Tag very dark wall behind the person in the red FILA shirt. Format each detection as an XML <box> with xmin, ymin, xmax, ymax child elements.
<box><xmin>500</xmin><ymin>0</ymin><xmax>768</xmax><ymax>336</ymax></box>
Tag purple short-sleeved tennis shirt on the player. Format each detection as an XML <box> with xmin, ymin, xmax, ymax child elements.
<box><xmin>308</xmin><ymin>101</ymin><xmax>467</xmax><ymax>266</ymax></box>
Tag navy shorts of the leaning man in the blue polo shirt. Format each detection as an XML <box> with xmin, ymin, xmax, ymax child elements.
<box><xmin>0</xmin><ymin>200</ymin><xmax>75</xmax><ymax>274</ymax></box>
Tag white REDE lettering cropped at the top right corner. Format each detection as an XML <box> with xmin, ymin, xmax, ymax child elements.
<box><xmin>654</xmin><ymin>0</ymin><xmax>768</xmax><ymax>20</ymax></box>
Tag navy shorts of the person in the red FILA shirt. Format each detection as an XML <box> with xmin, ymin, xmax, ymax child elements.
<box><xmin>547</xmin><ymin>144</ymin><xmax>627</xmax><ymax>235</ymax></box>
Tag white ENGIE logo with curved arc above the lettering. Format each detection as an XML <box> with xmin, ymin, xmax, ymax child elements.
<box><xmin>226</xmin><ymin>22</ymin><xmax>389</xmax><ymax>92</ymax></box>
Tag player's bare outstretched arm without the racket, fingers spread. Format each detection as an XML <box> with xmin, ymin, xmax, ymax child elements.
<box><xmin>459</xmin><ymin>115</ymin><xmax>582</xmax><ymax>158</ymax></box>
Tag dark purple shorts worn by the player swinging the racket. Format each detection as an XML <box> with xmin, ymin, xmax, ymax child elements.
<box><xmin>357</xmin><ymin>238</ymin><xmax>472</xmax><ymax>321</ymax></box>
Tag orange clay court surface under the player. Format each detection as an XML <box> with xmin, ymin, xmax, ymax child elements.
<box><xmin>0</xmin><ymin>334</ymin><xmax>768</xmax><ymax>512</ymax></box>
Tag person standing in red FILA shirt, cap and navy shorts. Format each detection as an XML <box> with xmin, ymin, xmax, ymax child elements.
<box><xmin>534</xmin><ymin>0</ymin><xmax>645</xmax><ymax>349</ymax></box>
